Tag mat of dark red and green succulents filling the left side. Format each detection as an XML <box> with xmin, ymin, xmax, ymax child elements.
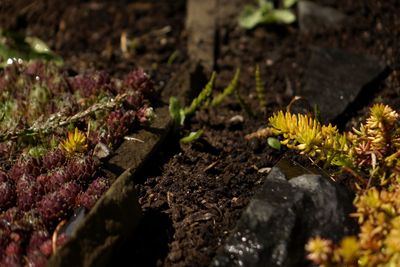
<box><xmin>0</xmin><ymin>58</ymin><xmax>155</xmax><ymax>266</ymax></box>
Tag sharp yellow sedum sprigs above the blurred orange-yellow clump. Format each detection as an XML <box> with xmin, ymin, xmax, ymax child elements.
<box><xmin>269</xmin><ymin>104</ymin><xmax>400</xmax><ymax>188</ymax></box>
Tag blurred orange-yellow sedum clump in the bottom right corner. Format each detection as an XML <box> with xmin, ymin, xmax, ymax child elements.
<box><xmin>306</xmin><ymin>184</ymin><xmax>400</xmax><ymax>267</ymax></box>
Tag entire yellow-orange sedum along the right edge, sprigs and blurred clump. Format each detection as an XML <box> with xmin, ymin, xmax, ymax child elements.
<box><xmin>253</xmin><ymin>104</ymin><xmax>400</xmax><ymax>267</ymax></box>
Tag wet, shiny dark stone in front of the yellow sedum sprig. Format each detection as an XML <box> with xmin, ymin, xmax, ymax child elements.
<box><xmin>211</xmin><ymin>159</ymin><xmax>355</xmax><ymax>267</ymax></box>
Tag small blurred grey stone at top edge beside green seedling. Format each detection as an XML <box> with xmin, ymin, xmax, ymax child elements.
<box><xmin>297</xmin><ymin>0</ymin><xmax>347</xmax><ymax>33</ymax></box>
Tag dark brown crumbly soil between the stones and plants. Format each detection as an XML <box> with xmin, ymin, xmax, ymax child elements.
<box><xmin>0</xmin><ymin>0</ymin><xmax>400</xmax><ymax>266</ymax></box>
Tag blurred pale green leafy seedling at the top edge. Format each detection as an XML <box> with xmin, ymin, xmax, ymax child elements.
<box><xmin>239</xmin><ymin>0</ymin><xmax>297</xmax><ymax>30</ymax></box>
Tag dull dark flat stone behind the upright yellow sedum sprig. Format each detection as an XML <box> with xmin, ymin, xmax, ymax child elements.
<box><xmin>298</xmin><ymin>48</ymin><xmax>386</xmax><ymax>123</ymax></box>
